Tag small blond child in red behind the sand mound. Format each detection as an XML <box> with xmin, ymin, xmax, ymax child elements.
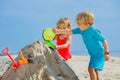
<box><xmin>56</xmin><ymin>18</ymin><xmax>72</xmax><ymax>63</ymax></box>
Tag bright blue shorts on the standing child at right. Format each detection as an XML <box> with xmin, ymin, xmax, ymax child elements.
<box><xmin>89</xmin><ymin>53</ymin><xmax>105</xmax><ymax>71</ymax></box>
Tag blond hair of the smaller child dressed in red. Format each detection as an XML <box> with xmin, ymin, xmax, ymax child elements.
<box><xmin>57</xmin><ymin>18</ymin><xmax>72</xmax><ymax>29</ymax></box>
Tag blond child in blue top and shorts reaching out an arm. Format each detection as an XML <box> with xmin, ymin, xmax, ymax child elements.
<box><xmin>54</xmin><ymin>11</ymin><xmax>109</xmax><ymax>80</ymax></box>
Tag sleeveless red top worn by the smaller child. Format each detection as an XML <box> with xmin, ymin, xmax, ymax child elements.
<box><xmin>57</xmin><ymin>34</ymin><xmax>72</xmax><ymax>60</ymax></box>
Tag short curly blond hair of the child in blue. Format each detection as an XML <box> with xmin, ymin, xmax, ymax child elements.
<box><xmin>76</xmin><ymin>11</ymin><xmax>95</xmax><ymax>25</ymax></box>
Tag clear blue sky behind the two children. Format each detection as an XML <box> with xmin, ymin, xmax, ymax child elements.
<box><xmin>0</xmin><ymin>0</ymin><xmax>120</xmax><ymax>54</ymax></box>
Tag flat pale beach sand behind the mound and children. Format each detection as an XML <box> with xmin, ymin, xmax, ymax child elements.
<box><xmin>0</xmin><ymin>55</ymin><xmax>120</xmax><ymax>80</ymax></box>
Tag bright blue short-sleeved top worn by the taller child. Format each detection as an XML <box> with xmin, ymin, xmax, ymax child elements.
<box><xmin>72</xmin><ymin>26</ymin><xmax>105</xmax><ymax>55</ymax></box>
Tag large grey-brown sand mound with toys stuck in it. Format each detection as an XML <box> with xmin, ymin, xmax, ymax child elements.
<box><xmin>1</xmin><ymin>41</ymin><xmax>78</xmax><ymax>80</ymax></box>
